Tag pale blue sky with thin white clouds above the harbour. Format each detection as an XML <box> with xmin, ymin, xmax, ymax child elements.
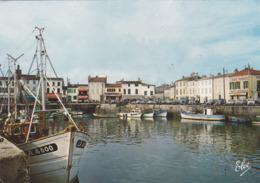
<box><xmin>0</xmin><ymin>0</ymin><xmax>260</xmax><ymax>86</ymax></box>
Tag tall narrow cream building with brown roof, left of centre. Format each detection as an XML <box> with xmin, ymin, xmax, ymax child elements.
<box><xmin>88</xmin><ymin>76</ymin><xmax>107</xmax><ymax>102</ymax></box>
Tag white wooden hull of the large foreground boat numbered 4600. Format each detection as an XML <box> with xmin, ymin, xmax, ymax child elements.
<box><xmin>18</xmin><ymin>131</ymin><xmax>88</xmax><ymax>183</ymax></box>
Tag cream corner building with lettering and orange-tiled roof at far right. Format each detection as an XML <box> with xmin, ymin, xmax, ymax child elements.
<box><xmin>229</xmin><ymin>66</ymin><xmax>260</xmax><ymax>100</ymax></box>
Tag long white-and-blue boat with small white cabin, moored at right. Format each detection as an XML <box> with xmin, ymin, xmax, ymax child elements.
<box><xmin>180</xmin><ymin>108</ymin><xmax>226</xmax><ymax>121</ymax></box>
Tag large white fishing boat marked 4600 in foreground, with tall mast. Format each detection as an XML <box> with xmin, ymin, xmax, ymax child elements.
<box><xmin>1</xmin><ymin>27</ymin><xmax>89</xmax><ymax>183</ymax></box>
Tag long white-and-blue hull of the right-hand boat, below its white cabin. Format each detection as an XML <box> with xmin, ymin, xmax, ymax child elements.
<box><xmin>180</xmin><ymin>111</ymin><xmax>226</xmax><ymax>121</ymax></box>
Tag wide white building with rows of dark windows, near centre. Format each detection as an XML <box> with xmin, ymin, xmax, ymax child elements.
<box><xmin>117</xmin><ymin>78</ymin><xmax>155</xmax><ymax>99</ymax></box>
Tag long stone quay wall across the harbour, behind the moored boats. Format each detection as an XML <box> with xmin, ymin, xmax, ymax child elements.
<box><xmin>95</xmin><ymin>104</ymin><xmax>260</xmax><ymax>117</ymax></box>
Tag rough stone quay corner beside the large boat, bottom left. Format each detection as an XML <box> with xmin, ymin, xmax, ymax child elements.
<box><xmin>0</xmin><ymin>136</ymin><xmax>30</xmax><ymax>183</ymax></box>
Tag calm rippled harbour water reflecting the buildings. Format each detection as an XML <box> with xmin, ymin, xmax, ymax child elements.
<box><xmin>73</xmin><ymin>118</ymin><xmax>260</xmax><ymax>183</ymax></box>
